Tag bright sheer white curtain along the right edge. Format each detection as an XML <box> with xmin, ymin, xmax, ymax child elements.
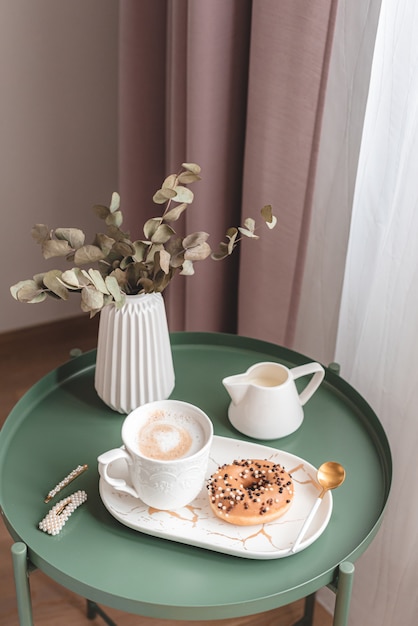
<box><xmin>336</xmin><ymin>0</ymin><xmax>418</xmax><ymax>626</ymax></box>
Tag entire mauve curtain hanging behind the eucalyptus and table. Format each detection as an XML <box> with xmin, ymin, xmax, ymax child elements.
<box><xmin>119</xmin><ymin>0</ymin><xmax>337</xmax><ymax>346</ymax></box>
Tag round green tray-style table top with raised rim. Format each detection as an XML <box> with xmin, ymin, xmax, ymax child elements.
<box><xmin>0</xmin><ymin>333</ymin><xmax>392</xmax><ymax>620</ymax></box>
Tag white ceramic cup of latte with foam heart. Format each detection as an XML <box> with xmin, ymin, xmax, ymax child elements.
<box><xmin>98</xmin><ymin>400</ymin><xmax>213</xmax><ymax>510</ymax></box>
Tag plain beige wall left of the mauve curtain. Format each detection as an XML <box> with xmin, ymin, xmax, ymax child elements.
<box><xmin>0</xmin><ymin>0</ymin><xmax>118</xmax><ymax>332</ymax></box>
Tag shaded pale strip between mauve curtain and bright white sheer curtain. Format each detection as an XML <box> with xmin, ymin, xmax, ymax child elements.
<box><xmin>293</xmin><ymin>0</ymin><xmax>381</xmax><ymax>364</ymax></box>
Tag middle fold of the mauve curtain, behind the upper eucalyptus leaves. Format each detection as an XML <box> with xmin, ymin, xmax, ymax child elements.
<box><xmin>165</xmin><ymin>0</ymin><xmax>251</xmax><ymax>332</ymax></box>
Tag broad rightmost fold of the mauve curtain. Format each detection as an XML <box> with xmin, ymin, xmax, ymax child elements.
<box><xmin>238</xmin><ymin>0</ymin><xmax>337</xmax><ymax>346</ymax></box>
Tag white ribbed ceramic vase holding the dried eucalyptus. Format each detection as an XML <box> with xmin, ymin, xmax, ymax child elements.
<box><xmin>94</xmin><ymin>293</ymin><xmax>174</xmax><ymax>413</ymax></box>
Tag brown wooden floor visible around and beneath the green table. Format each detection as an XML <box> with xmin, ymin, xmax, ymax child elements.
<box><xmin>0</xmin><ymin>316</ymin><xmax>332</xmax><ymax>626</ymax></box>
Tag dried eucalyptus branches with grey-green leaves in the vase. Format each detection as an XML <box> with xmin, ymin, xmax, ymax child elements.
<box><xmin>10</xmin><ymin>163</ymin><xmax>277</xmax><ymax>316</ymax></box>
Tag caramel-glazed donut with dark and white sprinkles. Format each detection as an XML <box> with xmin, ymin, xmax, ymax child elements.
<box><xmin>207</xmin><ymin>459</ymin><xmax>294</xmax><ymax>526</ymax></box>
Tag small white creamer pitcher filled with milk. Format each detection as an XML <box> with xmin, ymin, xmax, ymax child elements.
<box><xmin>222</xmin><ymin>362</ymin><xmax>325</xmax><ymax>439</ymax></box>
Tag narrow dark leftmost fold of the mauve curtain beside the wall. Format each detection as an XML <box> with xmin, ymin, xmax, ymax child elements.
<box><xmin>118</xmin><ymin>0</ymin><xmax>167</xmax><ymax>212</ymax></box>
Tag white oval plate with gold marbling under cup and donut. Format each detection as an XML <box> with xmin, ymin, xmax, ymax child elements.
<box><xmin>99</xmin><ymin>435</ymin><xmax>332</xmax><ymax>559</ymax></box>
